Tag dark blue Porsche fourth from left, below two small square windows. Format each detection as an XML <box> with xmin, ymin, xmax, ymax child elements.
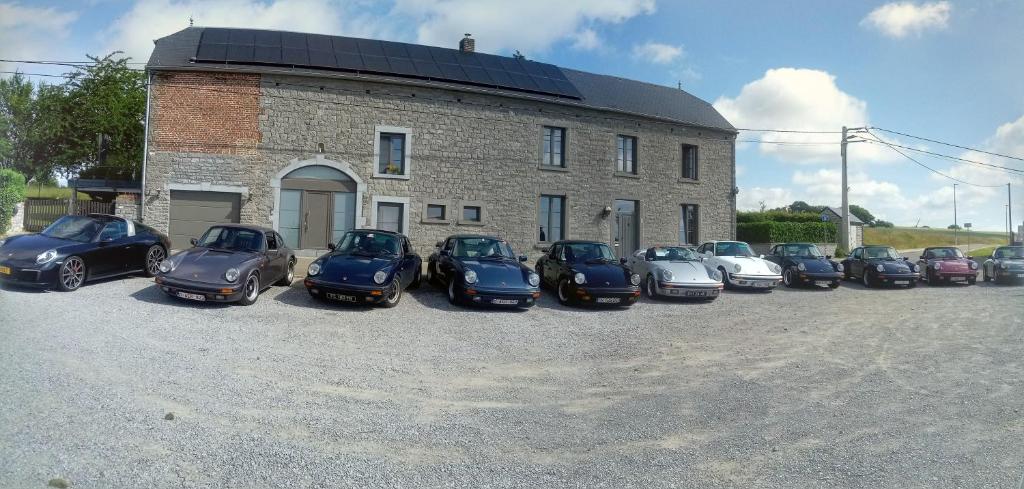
<box><xmin>427</xmin><ymin>235</ymin><xmax>541</xmax><ymax>307</ymax></box>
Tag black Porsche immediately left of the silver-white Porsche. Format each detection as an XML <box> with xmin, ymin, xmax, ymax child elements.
<box><xmin>537</xmin><ymin>240</ymin><xmax>640</xmax><ymax>306</ymax></box>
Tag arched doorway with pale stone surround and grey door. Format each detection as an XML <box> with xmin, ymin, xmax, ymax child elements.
<box><xmin>272</xmin><ymin>158</ymin><xmax>364</xmax><ymax>250</ymax></box>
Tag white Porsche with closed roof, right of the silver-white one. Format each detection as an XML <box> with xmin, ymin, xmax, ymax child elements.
<box><xmin>697</xmin><ymin>241</ymin><xmax>782</xmax><ymax>291</ymax></box>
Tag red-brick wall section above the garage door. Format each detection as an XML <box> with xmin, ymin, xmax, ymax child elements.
<box><xmin>150</xmin><ymin>72</ymin><xmax>260</xmax><ymax>154</ymax></box>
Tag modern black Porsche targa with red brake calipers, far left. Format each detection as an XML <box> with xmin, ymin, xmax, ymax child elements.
<box><xmin>0</xmin><ymin>214</ymin><xmax>171</xmax><ymax>291</ymax></box>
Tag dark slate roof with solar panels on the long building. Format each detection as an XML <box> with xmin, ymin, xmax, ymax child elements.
<box><xmin>146</xmin><ymin>27</ymin><xmax>736</xmax><ymax>133</ymax></box>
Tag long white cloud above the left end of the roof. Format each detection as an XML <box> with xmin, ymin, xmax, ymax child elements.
<box><xmin>100</xmin><ymin>0</ymin><xmax>383</xmax><ymax>61</ymax></box>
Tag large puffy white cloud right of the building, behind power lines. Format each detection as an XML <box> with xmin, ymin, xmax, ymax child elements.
<box><xmin>715</xmin><ymin>68</ymin><xmax>895</xmax><ymax>165</ymax></box>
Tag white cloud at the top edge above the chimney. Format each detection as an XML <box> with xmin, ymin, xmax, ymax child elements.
<box><xmin>392</xmin><ymin>0</ymin><xmax>655</xmax><ymax>53</ymax></box>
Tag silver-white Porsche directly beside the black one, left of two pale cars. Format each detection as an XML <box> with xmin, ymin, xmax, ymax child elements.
<box><xmin>628</xmin><ymin>247</ymin><xmax>723</xmax><ymax>300</ymax></box>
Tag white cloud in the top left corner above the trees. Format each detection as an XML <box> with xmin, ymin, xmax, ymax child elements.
<box><xmin>0</xmin><ymin>3</ymin><xmax>83</xmax><ymax>72</ymax></box>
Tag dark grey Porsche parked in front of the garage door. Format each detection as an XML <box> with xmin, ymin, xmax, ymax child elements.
<box><xmin>156</xmin><ymin>224</ymin><xmax>295</xmax><ymax>306</ymax></box>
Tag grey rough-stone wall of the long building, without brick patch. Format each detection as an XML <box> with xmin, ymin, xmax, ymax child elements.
<box><xmin>145</xmin><ymin>71</ymin><xmax>735</xmax><ymax>257</ymax></box>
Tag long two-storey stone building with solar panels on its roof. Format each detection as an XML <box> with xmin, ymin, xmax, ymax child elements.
<box><xmin>142</xmin><ymin>28</ymin><xmax>736</xmax><ymax>257</ymax></box>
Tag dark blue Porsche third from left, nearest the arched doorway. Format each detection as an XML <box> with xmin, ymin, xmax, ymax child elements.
<box><xmin>304</xmin><ymin>229</ymin><xmax>423</xmax><ymax>307</ymax></box>
